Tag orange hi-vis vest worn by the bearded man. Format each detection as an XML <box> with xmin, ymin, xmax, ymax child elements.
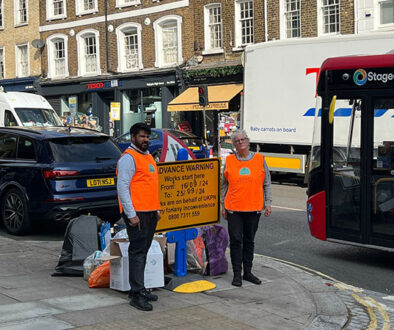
<box><xmin>116</xmin><ymin>148</ymin><xmax>161</xmax><ymax>213</ymax></box>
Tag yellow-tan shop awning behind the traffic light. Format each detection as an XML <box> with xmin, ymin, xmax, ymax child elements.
<box><xmin>167</xmin><ymin>84</ymin><xmax>244</xmax><ymax>111</ymax></box>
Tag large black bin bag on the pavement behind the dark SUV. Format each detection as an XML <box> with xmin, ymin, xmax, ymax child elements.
<box><xmin>52</xmin><ymin>215</ymin><xmax>101</xmax><ymax>276</ymax></box>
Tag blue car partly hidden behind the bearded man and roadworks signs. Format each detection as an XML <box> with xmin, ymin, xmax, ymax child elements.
<box><xmin>115</xmin><ymin>128</ymin><xmax>207</xmax><ymax>162</ymax></box>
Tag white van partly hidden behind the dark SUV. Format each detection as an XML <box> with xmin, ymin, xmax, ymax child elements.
<box><xmin>0</xmin><ymin>86</ymin><xmax>63</xmax><ymax>127</ymax></box>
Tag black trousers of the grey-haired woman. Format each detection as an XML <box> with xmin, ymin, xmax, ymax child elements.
<box><xmin>227</xmin><ymin>212</ymin><xmax>261</xmax><ymax>274</ymax></box>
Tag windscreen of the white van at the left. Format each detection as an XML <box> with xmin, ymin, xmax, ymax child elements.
<box><xmin>15</xmin><ymin>108</ymin><xmax>63</xmax><ymax>126</ymax></box>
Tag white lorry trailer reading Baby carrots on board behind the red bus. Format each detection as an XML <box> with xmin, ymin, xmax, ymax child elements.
<box><xmin>241</xmin><ymin>32</ymin><xmax>394</xmax><ymax>174</ymax></box>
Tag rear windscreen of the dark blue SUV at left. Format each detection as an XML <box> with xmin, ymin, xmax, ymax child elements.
<box><xmin>49</xmin><ymin>136</ymin><xmax>121</xmax><ymax>162</ymax></box>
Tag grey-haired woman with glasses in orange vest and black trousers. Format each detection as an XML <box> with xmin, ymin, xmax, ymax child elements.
<box><xmin>221</xmin><ymin>130</ymin><xmax>272</xmax><ymax>286</ymax></box>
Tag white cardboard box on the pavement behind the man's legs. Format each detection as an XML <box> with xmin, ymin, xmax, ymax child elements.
<box><xmin>109</xmin><ymin>240</ymin><xmax>164</xmax><ymax>291</ymax></box>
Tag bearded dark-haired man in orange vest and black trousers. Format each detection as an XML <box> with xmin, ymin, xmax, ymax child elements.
<box><xmin>117</xmin><ymin>123</ymin><xmax>160</xmax><ymax>311</ymax></box>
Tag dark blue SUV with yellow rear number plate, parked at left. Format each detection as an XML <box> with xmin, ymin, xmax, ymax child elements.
<box><xmin>0</xmin><ymin>127</ymin><xmax>121</xmax><ymax>235</ymax></box>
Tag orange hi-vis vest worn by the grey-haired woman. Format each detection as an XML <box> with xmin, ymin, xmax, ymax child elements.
<box><xmin>224</xmin><ymin>153</ymin><xmax>265</xmax><ymax>212</ymax></box>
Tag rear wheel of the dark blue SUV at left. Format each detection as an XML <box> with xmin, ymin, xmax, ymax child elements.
<box><xmin>1</xmin><ymin>188</ymin><xmax>31</xmax><ymax>235</ymax></box>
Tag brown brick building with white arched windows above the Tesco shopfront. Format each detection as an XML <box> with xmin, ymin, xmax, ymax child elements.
<box><xmin>39</xmin><ymin>0</ymin><xmax>193</xmax><ymax>133</ymax></box>
